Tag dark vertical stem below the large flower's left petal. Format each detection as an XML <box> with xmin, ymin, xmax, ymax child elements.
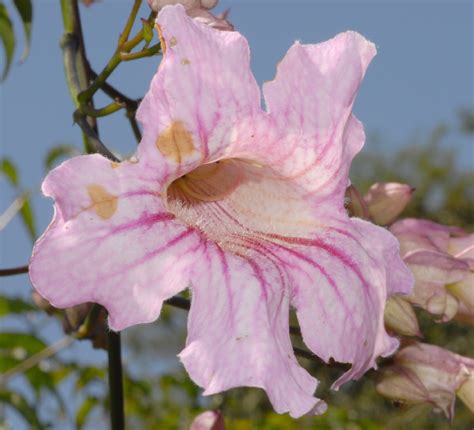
<box><xmin>107</xmin><ymin>331</ymin><xmax>125</xmax><ymax>430</ymax></box>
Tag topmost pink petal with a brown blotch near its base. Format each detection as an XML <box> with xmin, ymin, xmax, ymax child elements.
<box><xmin>137</xmin><ymin>4</ymin><xmax>263</xmax><ymax>182</ymax></box>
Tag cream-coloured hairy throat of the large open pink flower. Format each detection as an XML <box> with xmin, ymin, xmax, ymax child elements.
<box><xmin>166</xmin><ymin>159</ymin><xmax>315</xmax><ymax>253</ymax></box>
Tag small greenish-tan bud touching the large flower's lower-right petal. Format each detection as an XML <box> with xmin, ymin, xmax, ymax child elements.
<box><xmin>384</xmin><ymin>295</ymin><xmax>421</xmax><ymax>336</ymax></box>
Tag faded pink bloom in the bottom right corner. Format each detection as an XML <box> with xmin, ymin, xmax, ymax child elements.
<box><xmin>376</xmin><ymin>343</ymin><xmax>474</xmax><ymax>419</ymax></box>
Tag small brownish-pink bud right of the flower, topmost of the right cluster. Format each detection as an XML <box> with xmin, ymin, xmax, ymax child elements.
<box><xmin>364</xmin><ymin>182</ymin><xmax>415</xmax><ymax>225</ymax></box>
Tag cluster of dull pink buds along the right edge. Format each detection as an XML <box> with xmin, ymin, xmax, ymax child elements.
<box><xmin>346</xmin><ymin>183</ymin><xmax>474</xmax><ymax>419</ymax></box>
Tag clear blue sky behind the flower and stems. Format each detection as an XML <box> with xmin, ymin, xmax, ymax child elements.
<box><xmin>0</xmin><ymin>0</ymin><xmax>474</xmax><ymax>426</ymax></box>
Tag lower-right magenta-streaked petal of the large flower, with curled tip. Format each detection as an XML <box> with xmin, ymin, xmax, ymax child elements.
<box><xmin>254</xmin><ymin>220</ymin><xmax>413</xmax><ymax>388</ymax></box>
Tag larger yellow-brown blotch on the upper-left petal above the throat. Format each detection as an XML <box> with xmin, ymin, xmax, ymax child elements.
<box><xmin>156</xmin><ymin>121</ymin><xmax>194</xmax><ymax>164</ymax></box>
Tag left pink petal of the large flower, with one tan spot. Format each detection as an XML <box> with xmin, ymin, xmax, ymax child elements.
<box><xmin>30</xmin><ymin>155</ymin><xmax>201</xmax><ymax>330</ymax></box>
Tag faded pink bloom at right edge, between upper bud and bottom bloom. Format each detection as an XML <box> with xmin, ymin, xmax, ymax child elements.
<box><xmin>390</xmin><ymin>218</ymin><xmax>474</xmax><ymax>321</ymax></box>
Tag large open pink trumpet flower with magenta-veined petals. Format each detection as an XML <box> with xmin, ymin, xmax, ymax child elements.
<box><xmin>30</xmin><ymin>5</ymin><xmax>412</xmax><ymax>417</ymax></box>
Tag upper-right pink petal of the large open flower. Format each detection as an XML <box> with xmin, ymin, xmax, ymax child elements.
<box><xmin>263</xmin><ymin>32</ymin><xmax>376</xmax><ymax>210</ymax></box>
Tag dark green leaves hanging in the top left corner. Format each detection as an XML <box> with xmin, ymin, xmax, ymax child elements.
<box><xmin>0</xmin><ymin>0</ymin><xmax>33</xmax><ymax>81</ymax></box>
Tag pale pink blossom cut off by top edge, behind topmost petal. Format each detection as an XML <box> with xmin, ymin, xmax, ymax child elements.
<box><xmin>147</xmin><ymin>0</ymin><xmax>234</xmax><ymax>31</ymax></box>
